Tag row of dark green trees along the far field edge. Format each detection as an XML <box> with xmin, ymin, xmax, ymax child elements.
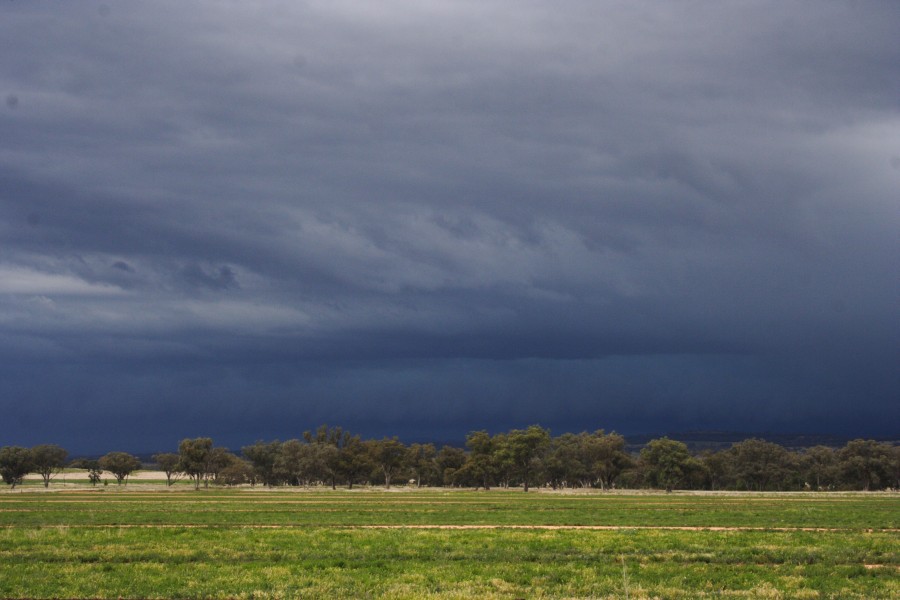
<box><xmin>0</xmin><ymin>425</ymin><xmax>900</xmax><ymax>492</ymax></box>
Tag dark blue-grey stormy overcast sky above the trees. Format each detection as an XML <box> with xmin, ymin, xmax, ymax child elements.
<box><xmin>0</xmin><ymin>0</ymin><xmax>900</xmax><ymax>452</ymax></box>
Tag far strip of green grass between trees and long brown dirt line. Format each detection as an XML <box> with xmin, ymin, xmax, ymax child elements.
<box><xmin>0</xmin><ymin>486</ymin><xmax>900</xmax><ymax>529</ymax></box>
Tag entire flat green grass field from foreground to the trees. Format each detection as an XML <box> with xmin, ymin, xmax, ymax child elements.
<box><xmin>0</xmin><ymin>485</ymin><xmax>900</xmax><ymax>599</ymax></box>
